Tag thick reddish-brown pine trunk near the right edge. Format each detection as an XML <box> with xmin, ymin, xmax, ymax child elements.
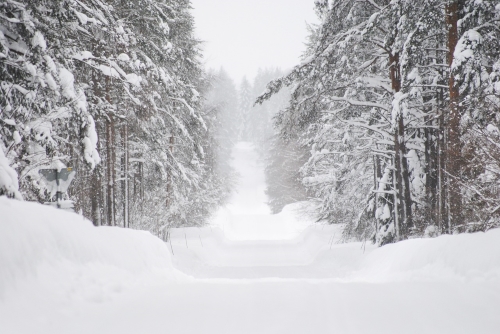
<box><xmin>446</xmin><ymin>0</ymin><xmax>463</xmax><ymax>233</ymax></box>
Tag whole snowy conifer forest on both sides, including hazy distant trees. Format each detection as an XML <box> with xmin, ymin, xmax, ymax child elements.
<box><xmin>0</xmin><ymin>0</ymin><xmax>500</xmax><ymax>245</ymax></box>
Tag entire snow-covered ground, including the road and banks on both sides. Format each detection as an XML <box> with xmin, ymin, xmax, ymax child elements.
<box><xmin>0</xmin><ymin>143</ymin><xmax>500</xmax><ymax>334</ymax></box>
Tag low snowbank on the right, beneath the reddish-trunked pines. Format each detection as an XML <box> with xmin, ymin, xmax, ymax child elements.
<box><xmin>351</xmin><ymin>229</ymin><xmax>500</xmax><ymax>282</ymax></box>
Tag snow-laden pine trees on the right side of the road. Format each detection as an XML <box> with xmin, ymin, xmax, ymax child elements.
<box><xmin>257</xmin><ymin>0</ymin><xmax>500</xmax><ymax>245</ymax></box>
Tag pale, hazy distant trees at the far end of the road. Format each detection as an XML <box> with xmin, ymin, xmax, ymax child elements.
<box><xmin>207</xmin><ymin>68</ymin><xmax>309</xmax><ymax>213</ymax></box>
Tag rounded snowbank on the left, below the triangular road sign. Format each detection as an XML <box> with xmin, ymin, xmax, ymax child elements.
<box><xmin>0</xmin><ymin>197</ymin><xmax>174</xmax><ymax>299</ymax></box>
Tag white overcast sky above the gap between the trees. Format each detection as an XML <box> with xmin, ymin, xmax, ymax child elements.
<box><xmin>191</xmin><ymin>0</ymin><xmax>318</xmax><ymax>83</ymax></box>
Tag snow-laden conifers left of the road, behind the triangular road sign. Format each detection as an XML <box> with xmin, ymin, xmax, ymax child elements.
<box><xmin>0</xmin><ymin>0</ymin><xmax>229</xmax><ymax>236</ymax></box>
